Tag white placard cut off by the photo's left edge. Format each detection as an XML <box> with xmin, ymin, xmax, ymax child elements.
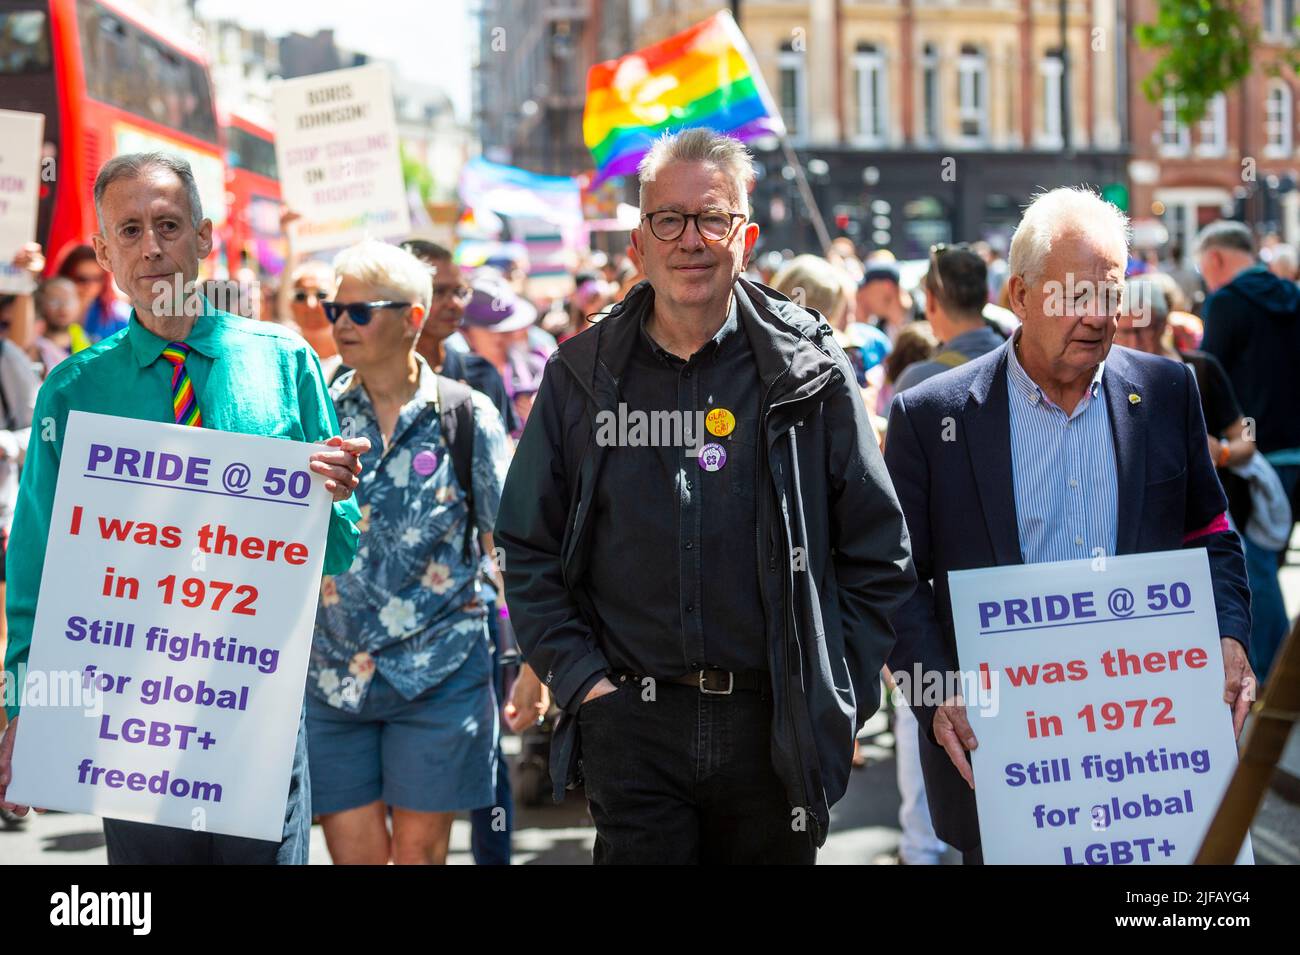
<box><xmin>0</xmin><ymin>109</ymin><xmax>46</xmax><ymax>295</ymax></box>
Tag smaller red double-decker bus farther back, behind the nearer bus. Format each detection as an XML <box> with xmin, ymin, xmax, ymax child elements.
<box><xmin>225</xmin><ymin>113</ymin><xmax>285</xmax><ymax>275</ymax></box>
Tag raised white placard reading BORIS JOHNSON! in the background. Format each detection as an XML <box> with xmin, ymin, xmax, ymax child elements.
<box><xmin>272</xmin><ymin>64</ymin><xmax>411</xmax><ymax>252</ymax></box>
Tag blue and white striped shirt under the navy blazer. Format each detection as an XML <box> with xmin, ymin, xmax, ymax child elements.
<box><xmin>1006</xmin><ymin>346</ymin><xmax>1119</xmax><ymax>564</ymax></box>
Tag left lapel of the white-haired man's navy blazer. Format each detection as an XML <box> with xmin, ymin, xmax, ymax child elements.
<box><xmin>962</xmin><ymin>346</ymin><xmax>1023</xmax><ymax>565</ymax></box>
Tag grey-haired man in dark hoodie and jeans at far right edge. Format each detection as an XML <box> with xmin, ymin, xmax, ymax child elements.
<box><xmin>1196</xmin><ymin>221</ymin><xmax>1300</xmax><ymax>678</ymax></box>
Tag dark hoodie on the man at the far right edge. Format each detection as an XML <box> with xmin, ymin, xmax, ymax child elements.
<box><xmin>1201</xmin><ymin>266</ymin><xmax>1300</xmax><ymax>453</ymax></box>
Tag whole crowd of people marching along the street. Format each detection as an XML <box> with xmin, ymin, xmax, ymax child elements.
<box><xmin>0</xmin><ymin>130</ymin><xmax>1300</xmax><ymax>864</ymax></box>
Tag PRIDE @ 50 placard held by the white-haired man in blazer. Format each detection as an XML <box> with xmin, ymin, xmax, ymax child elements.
<box><xmin>949</xmin><ymin>548</ymin><xmax>1252</xmax><ymax>865</ymax></box>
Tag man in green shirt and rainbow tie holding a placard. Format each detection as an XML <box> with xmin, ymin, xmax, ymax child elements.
<box><xmin>0</xmin><ymin>153</ymin><xmax>369</xmax><ymax>864</ymax></box>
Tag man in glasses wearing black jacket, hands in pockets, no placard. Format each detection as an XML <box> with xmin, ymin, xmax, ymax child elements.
<box><xmin>497</xmin><ymin>130</ymin><xmax>915</xmax><ymax>863</ymax></box>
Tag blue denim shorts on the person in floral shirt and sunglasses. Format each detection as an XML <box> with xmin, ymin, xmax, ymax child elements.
<box><xmin>307</xmin><ymin>642</ymin><xmax>499</xmax><ymax>815</ymax></box>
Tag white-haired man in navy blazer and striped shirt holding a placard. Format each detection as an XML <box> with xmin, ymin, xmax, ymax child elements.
<box><xmin>885</xmin><ymin>188</ymin><xmax>1255</xmax><ymax>863</ymax></box>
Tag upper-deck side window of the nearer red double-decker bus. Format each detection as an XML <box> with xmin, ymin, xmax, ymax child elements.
<box><xmin>77</xmin><ymin>0</ymin><xmax>217</xmax><ymax>143</ymax></box>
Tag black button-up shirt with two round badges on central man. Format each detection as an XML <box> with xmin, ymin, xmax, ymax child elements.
<box><xmin>589</xmin><ymin>301</ymin><xmax>768</xmax><ymax>678</ymax></box>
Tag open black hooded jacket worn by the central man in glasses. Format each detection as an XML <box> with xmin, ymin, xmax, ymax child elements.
<box><xmin>495</xmin><ymin>278</ymin><xmax>915</xmax><ymax>845</ymax></box>
